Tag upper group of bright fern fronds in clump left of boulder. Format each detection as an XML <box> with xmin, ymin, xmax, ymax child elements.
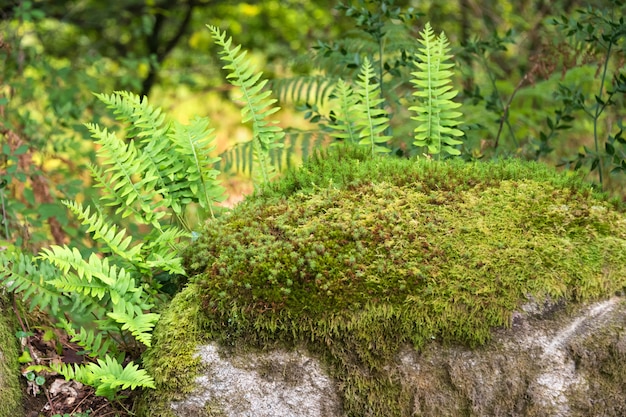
<box><xmin>88</xmin><ymin>92</ymin><xmax>223</xmax><ymax>224</ymax></box>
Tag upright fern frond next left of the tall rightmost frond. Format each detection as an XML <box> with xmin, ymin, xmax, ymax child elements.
<box><xmin>354</xmin><ymin>58</ymin><xmax>391</xmax><ymax>155</ymax></box>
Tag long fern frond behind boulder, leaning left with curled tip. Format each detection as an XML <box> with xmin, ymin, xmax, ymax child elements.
<box><xmin>208</xmin><ymin>26</ymin><xmax>284</xmax><ymax>183</ymax></box>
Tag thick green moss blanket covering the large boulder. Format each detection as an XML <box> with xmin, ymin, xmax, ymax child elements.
<box><xmin>144</xmin><ymin>148</ymin><xmax>626</xmax><ymax>416</ymax></box>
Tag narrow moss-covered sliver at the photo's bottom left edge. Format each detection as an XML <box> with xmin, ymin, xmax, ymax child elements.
<box><xmin>0</xmin><ymin>299</ymin><xmax>23</xmax><ymax>417</ymax></box>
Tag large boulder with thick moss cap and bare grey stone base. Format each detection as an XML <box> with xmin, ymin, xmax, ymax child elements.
<box><xmin>140</xmin><ymin>148</ymin><xmax>626</xmax><ymax>417</ymax></box>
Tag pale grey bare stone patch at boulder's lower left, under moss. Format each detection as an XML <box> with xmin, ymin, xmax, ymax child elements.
<box><xmin>172</xmin><ymin>344</ymin><xmax>341</xmax><ymax>417</ymax></box>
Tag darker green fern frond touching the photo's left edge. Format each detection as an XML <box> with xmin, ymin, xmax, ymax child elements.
<box><xmin>0</xmin><ymin>252</ymin><xmax>68</xmax><ymax>316</ymax></box>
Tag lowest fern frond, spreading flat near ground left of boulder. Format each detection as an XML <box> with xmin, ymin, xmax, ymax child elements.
<box><xmin>50</xmin><ymin>355</ymin><xmax>155</xmax><ymax>400</ymax></box>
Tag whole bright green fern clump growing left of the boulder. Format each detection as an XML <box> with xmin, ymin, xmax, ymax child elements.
<box><xmin>0</xmin><ymin>92</ymin><xmax>229</xmax><ymax>398</ymax></box>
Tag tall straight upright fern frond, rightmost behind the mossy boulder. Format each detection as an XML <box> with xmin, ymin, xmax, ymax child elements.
<box><xmin>409</xmin><ymin>23</ymin><xmax>463</xmax><ymax>155</ymax></box>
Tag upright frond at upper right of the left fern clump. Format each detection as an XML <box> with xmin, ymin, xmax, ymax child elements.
<box><xmin>168</xmin><ymin>117</ymin><xmax>225</xmax><ymax>217</ymax></box>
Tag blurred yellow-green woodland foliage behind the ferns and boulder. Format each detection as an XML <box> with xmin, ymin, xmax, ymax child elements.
<box><xmin>0</xmin><ymin>0</ymin><xmax>626</xmax><ymax>251</ymax></box>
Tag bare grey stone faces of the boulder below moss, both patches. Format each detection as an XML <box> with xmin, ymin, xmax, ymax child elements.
<box><xmin>171</xmin><ymin>297</ymin><xmax>626</xmax><ymax>417</ymax></box>
